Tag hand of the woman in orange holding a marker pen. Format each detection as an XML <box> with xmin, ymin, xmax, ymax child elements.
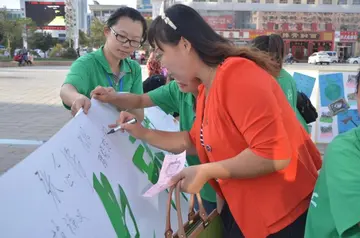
<box><xmin>108</xmin><ymin>111</ymin><xmax>148</xmax><ymax>139</ymax></box>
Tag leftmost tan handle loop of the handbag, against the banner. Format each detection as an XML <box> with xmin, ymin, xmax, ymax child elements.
<box><xmin>165</xmin><ymin>182</ymin><xmax>186</xmax><ymax>238</ymax></box>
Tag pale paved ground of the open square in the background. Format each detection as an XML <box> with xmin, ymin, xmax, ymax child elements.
<box><xmin>0</xmin><ymin>64</ymin><xmax>358</xmax><ymax>174</ymax></box>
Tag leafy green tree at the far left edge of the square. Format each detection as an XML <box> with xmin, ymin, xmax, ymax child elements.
<box><xmin>0</xmin><ymin>9</ymin><xmax>34</xmax><ymax>55</ymax></box>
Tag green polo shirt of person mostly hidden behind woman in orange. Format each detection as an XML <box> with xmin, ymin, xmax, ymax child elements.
<box><xmin>148</xmin><ymin>81</ymin><xmax>216</xmax><ymax>202</ymax></box>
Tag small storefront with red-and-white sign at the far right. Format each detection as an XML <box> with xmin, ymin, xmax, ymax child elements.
<box><xmin>334</xmin><ymin>31</ymin><xmax>358</xmax><ymax>61</ymax></box>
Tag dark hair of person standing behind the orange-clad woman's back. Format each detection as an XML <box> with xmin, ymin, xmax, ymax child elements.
<box><xmin>252</xmin><ymin>34</ymin><xmax>285</xmax><ymax>67</ymax></box>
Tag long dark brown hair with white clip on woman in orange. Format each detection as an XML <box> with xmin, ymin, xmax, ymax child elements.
<box><xmin>148</xmin><ymin>4</ymin><xmax>279</xmax><ymax>77</ymax></box>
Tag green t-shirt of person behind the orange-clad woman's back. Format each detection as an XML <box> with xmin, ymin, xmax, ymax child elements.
<box><xmin>276</xmin><ymin>69</ymin><xmax>309</xmax><ymax>133</ymax></box>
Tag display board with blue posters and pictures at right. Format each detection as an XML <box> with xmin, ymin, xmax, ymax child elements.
<box><xmin>288</xmin><ymin>70</ymin><xmax>360</xmax><ymax>144</ymax></box>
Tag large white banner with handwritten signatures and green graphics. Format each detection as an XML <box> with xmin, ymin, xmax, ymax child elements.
<box><xmin>0</xmin><ymin>100</ymin><xmax>188</xmax><ymax>238</ymax></box>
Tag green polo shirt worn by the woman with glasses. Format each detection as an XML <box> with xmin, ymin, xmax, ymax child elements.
<box><xmin>64</xmin><ymin>46</ymin><xmax>143</xmax><ymax>109</ymax></box>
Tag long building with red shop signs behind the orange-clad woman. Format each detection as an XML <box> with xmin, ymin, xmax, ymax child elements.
<box><xmin>178</xmin><ymin>0</ymin><xmax>360</xmax><ymax>59</ymax></box>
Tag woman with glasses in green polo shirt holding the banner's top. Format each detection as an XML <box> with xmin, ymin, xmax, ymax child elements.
<box><xmin>60</xmin><ymin>7</ymin><xmax>147</xmax><ymax>120</ymax></box>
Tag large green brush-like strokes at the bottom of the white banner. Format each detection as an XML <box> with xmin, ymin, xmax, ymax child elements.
<box><xmin>93</xmin><ymin>173</ymin><xmax>140</xmax><ymax>238</ymax></box>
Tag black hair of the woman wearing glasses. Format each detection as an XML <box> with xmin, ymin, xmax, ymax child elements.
<box><xmin>106</xmin><ymin>7</ymin><xmax>147</xmax><ymax>44</ymax></box>
